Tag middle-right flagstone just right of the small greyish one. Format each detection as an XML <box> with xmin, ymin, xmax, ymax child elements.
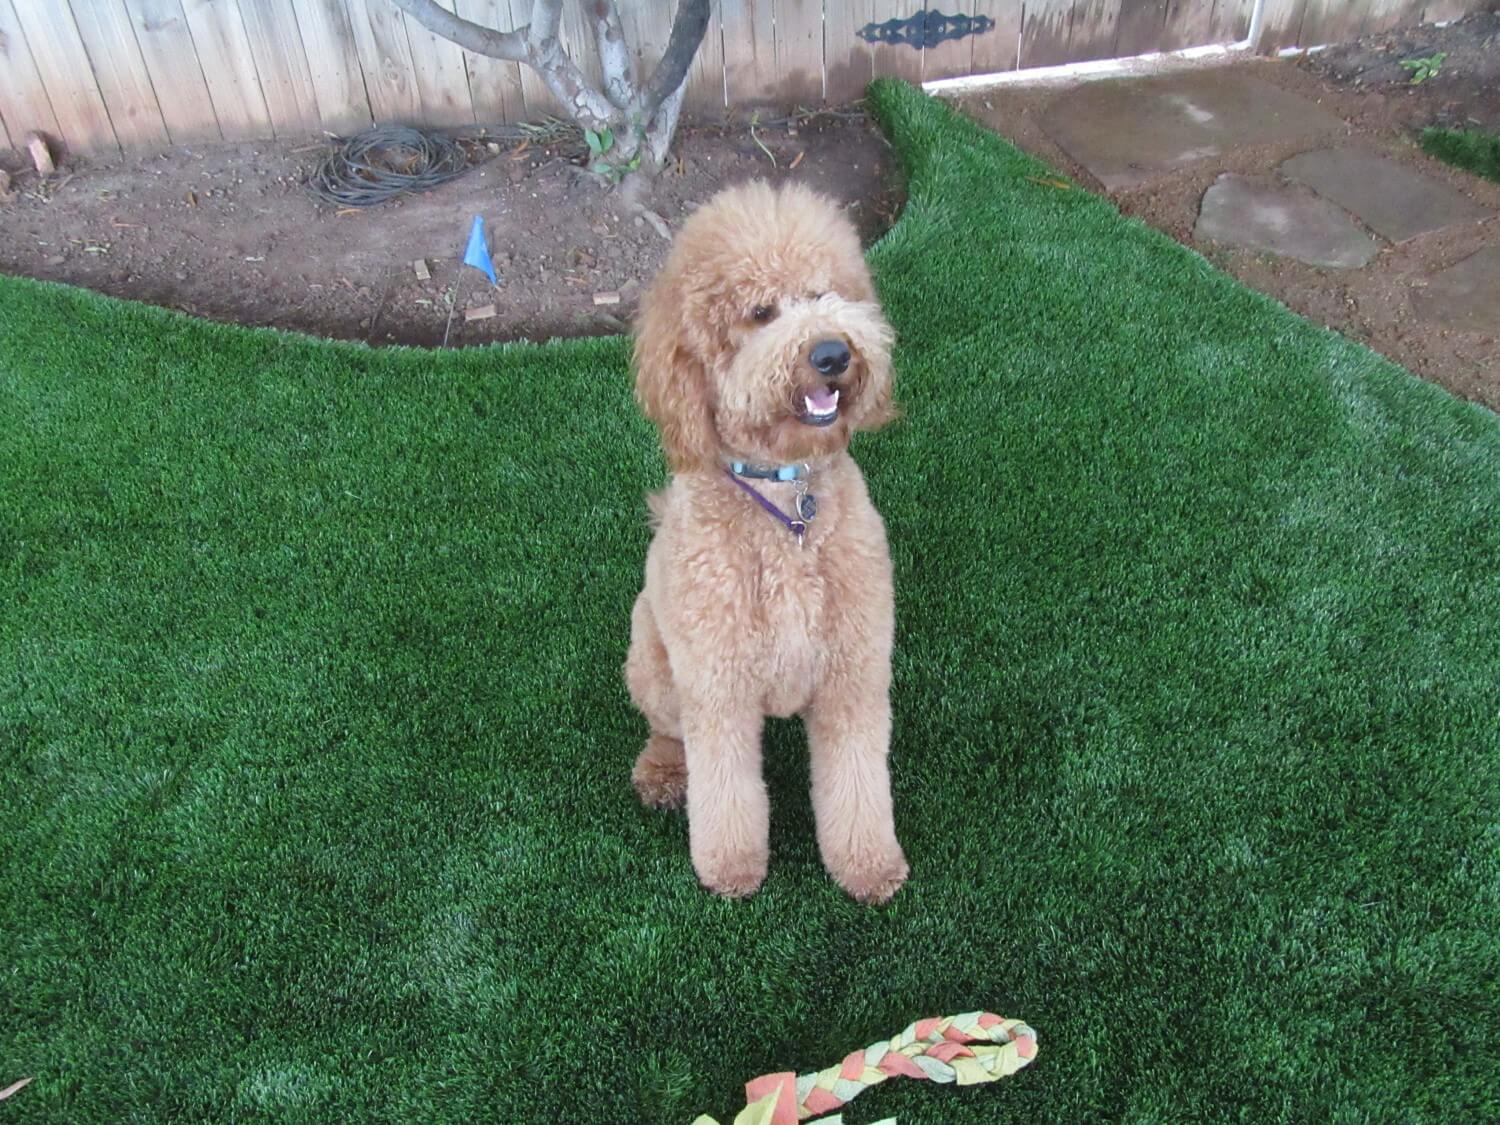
<box><xmin>1281</xmin><ymin>149</ymin><xmax>1490</xmax><ymax>242</ymax></box>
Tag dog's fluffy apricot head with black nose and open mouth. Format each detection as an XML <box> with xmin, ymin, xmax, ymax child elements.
<box><xmin>635</xmin><ymin>183</ymin><xmax>893</xmax><ymax>471</ymax></box>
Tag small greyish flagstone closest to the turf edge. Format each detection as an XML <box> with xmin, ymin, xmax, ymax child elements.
<box><xmin>1193</xmin><ymin>176</ymin><xmax>1380</xmax><ymax>270</ymax></box>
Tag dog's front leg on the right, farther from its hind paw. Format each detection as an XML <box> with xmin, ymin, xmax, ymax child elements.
<box><xmin>804</xmin><ymin>693</ymin><xmax>908</xmax><ymax>903</ymax></box>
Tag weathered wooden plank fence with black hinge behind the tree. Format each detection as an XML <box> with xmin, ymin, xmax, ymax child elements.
<box><xmin>0</xmin><ymin>0</ymin><xmax>1490</xmax><ymax>152</ymax></box>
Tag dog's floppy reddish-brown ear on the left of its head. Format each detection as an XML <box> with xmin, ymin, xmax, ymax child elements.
<box><xmin>635</xmin><ymin>276</ymin><xmax>719</xmax><ymax>473</ymax></box>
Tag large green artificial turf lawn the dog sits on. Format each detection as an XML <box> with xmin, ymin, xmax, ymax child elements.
<box><xmin>0</xmin><ymin>84</ymin><xmax>1500</xmax><ymax>1125</ymax></box>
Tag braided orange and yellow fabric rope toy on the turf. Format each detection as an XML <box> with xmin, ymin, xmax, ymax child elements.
<box><xmin>693</xmin><ymin>1011</ymin><xmax>1037</xmax><ymax>1125</ymax></box>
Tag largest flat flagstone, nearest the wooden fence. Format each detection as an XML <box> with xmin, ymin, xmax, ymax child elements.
<box><xmin>1038</xmin><ymin>71</ymin><xmax>1343</xmax><ymax>191</ymax></box>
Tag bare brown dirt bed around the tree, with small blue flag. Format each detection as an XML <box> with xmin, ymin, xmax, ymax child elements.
<box><xmin>0</xmin><ymin>110</ymin><xmax>902</xmax><ymax>345</ymax></box>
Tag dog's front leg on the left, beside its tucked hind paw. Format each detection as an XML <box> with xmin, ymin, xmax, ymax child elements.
<box><xmin>683</xmin><ymin>699</ymin><xmax>771</xmax><ymax>899</ymax></box>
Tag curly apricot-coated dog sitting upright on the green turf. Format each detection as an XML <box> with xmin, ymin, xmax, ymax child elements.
<box><xmin>626</xmin><ymin>183</ymin><xmax>908</xmax><ymax>903</ymax></box>
